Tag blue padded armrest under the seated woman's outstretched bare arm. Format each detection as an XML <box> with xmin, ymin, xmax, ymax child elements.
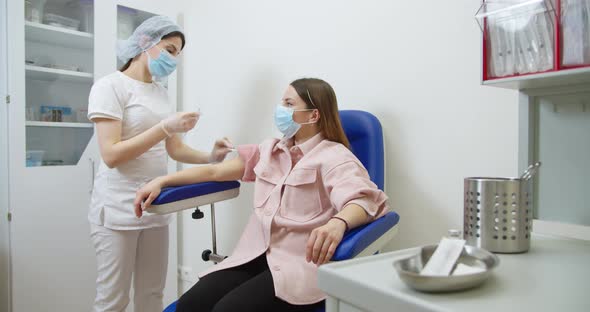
<box><xmin>147</xmin><ymin>181</ymin><xmax>240</xmax><ymax>214</ymax></box>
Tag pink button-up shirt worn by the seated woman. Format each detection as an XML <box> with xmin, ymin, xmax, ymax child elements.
<box><xmin>200</xmin><ymin>134</ymin><xmax>389</xmax><ymax>304</ymax></box>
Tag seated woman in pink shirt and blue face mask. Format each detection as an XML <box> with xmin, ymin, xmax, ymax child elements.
<box><xmin>135</xmin><ymin>79</ymin><xmax>389</xmax><ymax>312</ymax></box>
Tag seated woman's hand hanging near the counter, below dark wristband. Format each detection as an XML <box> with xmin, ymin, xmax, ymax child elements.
<box><xmin>305</xmin><ymin>219</ymin><xmax>346</xmax><ymax>265</ymax></box>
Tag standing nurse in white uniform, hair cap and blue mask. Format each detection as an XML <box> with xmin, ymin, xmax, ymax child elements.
<box><xmin>88</xmin><ymin>16</ymin><xmax>231</xmax><ymax>312</ymax></box>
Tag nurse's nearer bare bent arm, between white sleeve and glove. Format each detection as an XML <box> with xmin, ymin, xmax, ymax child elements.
<box><xmin>92</xmin><ymin>118</ymin><xmax>168</xmax><ymax>168</ymax></box>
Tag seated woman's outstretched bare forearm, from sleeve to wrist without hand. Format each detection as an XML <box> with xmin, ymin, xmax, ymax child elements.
<box><xmin>158</xmin><ymin>157</ymin><xmax>244</xmax><ymax>187</ymax></box>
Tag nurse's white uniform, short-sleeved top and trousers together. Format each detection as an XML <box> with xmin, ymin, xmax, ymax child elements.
<box><xmin>88</xmin><ymin>71</ymin><xmax>172</xmax><ymax>312</ymax></box>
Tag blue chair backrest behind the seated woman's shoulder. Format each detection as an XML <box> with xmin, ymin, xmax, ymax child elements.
<box><xmin>340</xmin><ymin>110</ymin><xmax>385</xmax><ymax>190</ymax></box>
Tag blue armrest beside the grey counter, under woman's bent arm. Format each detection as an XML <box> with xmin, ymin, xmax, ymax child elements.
<box><xmin>332</xmin><ymin>211</ymin><xmax>399</xmax><ymax>261</ymax></box>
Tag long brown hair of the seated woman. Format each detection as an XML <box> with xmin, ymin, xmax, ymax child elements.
<box><xmin>291</xmin><ymin>78</ymin><xmax>350</xmax><ymax>149</ymax></box>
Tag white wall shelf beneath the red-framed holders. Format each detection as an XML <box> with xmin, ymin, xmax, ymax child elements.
<box><xmin>482</xmin><ymin>67</ymin><xmax>590</xmax><ymax>90</ymax></box>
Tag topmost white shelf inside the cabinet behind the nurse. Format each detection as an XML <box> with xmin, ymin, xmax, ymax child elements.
<box><xmin>25</xmin><ymin>21</ymin><xmax>94</xmax><ymax>50</ymax></box>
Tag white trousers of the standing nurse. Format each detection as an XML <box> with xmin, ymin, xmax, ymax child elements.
<box><xmin>90</xmin><ymin>224</ymin><xmax>168</xmax><ymax>312</ymax></box>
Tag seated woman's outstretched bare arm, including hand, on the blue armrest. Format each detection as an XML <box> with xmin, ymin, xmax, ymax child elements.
<box><xmin>133</xmin><ymin>157</ymin><xmax>245</xmax><ymax>217</ymax></box>
